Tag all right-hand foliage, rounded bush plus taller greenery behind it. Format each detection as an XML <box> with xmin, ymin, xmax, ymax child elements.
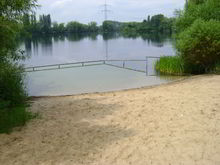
<box><xmin>157</xmin><ymin>0</ymin><xmax>220</xmax><ymax>74</ymax></box>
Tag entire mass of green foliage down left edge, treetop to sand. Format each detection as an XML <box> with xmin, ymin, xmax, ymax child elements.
<box><xmin>0</xmin><ymin>0</ymin><xmax>36</xmax><ymax>132</ymax></box>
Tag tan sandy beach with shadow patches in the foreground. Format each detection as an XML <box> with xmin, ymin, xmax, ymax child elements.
<box><xmin>0</xmin><ymin>76</ymin><xmax>220</xmax><ymax>165</ymax></box>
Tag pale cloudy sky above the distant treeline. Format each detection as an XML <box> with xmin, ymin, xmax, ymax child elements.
<box><xmin>37</xmin><ymin>0</ymin><xmax>185</xmax><ymax>24</ymax></box>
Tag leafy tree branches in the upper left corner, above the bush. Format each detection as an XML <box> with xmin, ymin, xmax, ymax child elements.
<box><xmin>0</xmin><ymin>0</ymin><xmax>36</xmax><ymax>62</ymax></box>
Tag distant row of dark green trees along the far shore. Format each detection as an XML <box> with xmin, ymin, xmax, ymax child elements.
<box><xmin>22</xmin><ymin>14</ymin><xmax>174</xmax><ymax>36</ymax></box>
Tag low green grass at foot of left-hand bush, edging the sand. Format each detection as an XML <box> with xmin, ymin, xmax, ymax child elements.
<box><xmin>0</xmin><ymin>101</ymin><xmax>36</xmax><ymax>133</ymax></box>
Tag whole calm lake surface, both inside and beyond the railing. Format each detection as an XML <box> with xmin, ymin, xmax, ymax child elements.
<box><xmin>21</xmin><ymin>33</ymin><xmax>178</xmax><ymax>96</ymax></box>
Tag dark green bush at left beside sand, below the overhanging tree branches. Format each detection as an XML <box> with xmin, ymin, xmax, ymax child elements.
<box><xmin>0</xmin><ymin>63</ymin><xmax>34</xmax><ymax>133</ymax></box>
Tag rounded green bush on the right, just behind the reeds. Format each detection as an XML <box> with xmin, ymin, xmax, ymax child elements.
<box><xmin>176</xmin><ymin>19</ymin><xmax>220</xmax><ymax>74</ymax></box>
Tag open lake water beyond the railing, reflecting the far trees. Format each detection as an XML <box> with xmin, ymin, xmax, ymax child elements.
<box><xmin>22</xmin><ymin>33</ymin><xmax>175</xmax><ymax>66</ymax></box>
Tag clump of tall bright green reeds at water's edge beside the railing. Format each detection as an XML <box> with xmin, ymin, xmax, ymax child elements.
<box><xmin>156</xmin><ymin>56</ymin><xmax>184</xmax><ymax>75</ymax></box>
